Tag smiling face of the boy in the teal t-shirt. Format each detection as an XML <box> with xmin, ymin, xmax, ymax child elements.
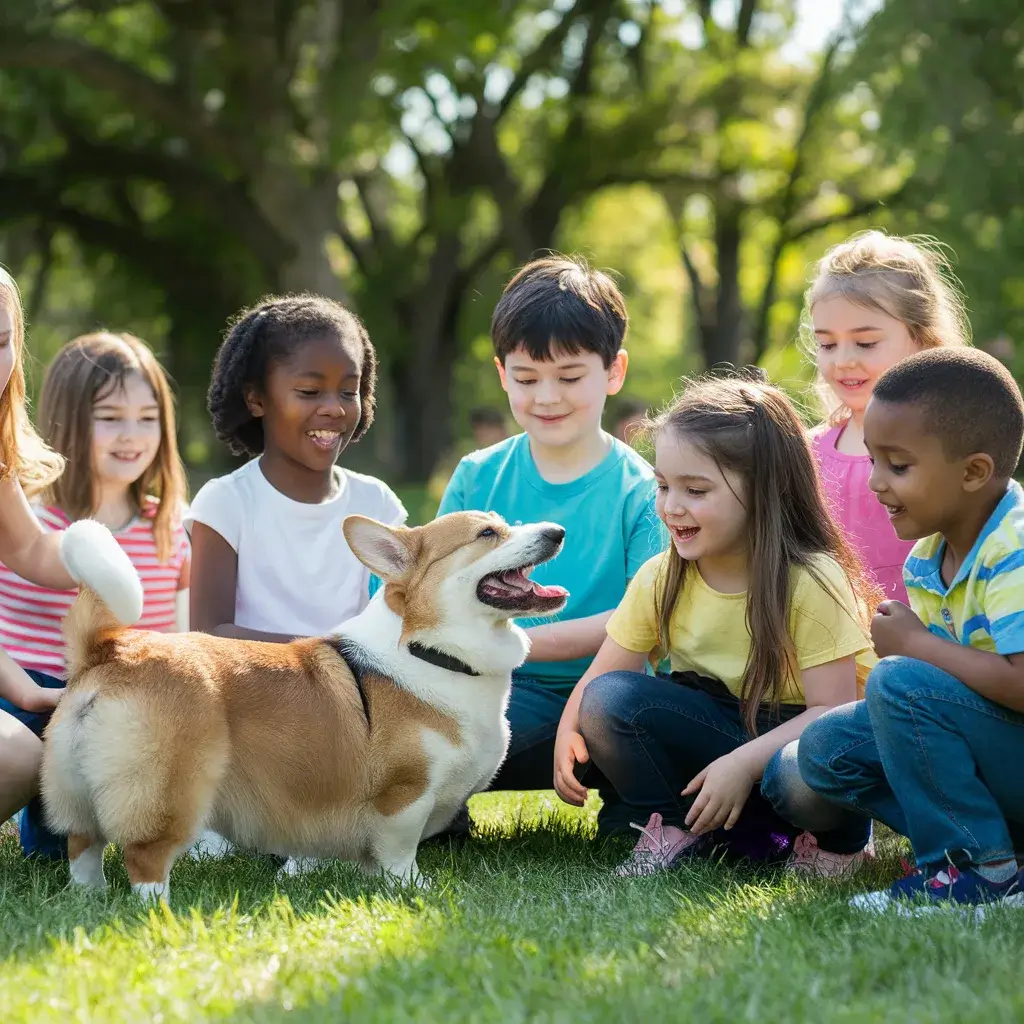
<box><xmin>495</xmin><ymin>346</ymin><xmax>627</xmax><ymax>449</ymax></box>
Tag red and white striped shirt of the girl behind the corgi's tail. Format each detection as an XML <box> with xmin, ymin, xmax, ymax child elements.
<box><xmin>0</xmin><ymin>506</ymin><xmax>189</xmax><ymax>679</ymax></box>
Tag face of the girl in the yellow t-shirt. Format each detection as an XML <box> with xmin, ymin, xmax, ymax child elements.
<box><xmin>654</xmin><ymin>429</ymin><xmax>748</xmax><ymax>561</ymax></box>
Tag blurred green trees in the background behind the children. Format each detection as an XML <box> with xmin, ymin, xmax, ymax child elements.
<box><xmin>0</xmin><ymin>0</ymin><xmax>1024</xmax><ymax>503</ymax></box>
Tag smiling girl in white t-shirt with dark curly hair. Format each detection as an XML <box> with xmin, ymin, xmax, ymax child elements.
<box><xmin>186</xmin><ymin>295</ymin><xmax>407</xmax><ymax>642</ymax></box>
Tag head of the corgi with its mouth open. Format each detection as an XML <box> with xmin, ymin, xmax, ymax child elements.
<box><xmin>343</xmin><ymin>512</ymin><xmax>568</xmax><ymax>639</ymax></box>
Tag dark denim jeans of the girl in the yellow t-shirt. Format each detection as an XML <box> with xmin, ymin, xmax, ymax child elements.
<box><xmin>580</xmin><ymin>672</ymin><xmax>804</xmax><ymax>856</ymax></box>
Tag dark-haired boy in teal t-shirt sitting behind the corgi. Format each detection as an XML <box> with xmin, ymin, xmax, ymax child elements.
<box><xmin>438</xmin><ymin>256</ymin><xmax>665</xmax><ymax>831</ymax></box>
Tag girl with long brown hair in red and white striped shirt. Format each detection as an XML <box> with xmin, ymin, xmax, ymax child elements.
<box><xmin>0</xmin><ymin>331</ymin><xmax>188</xmax><ymax>855</ymax></box>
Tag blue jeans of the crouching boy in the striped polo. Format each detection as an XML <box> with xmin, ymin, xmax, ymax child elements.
<box><xmin>799</xmin><ymin>657</ymin><xmax>1024</xmax><ymax>869</ymax></box>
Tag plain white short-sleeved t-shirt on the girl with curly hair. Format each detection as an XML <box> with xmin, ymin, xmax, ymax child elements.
<box><xmin>184</xmin><ymin>458</ymin><xmax>409</xmax><ymax>636</ymax></box>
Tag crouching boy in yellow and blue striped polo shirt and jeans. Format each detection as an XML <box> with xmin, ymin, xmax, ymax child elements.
<box><xmin>800</xmin><ymin>348</ymin><xmax>1024</xmax><ymax>909</ymax></box>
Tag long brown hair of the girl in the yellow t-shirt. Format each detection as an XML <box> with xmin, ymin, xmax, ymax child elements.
<box><xmin>648</xmin><ymin>375</ymin><xmax>881</xmax><ymax>735</ymax></box>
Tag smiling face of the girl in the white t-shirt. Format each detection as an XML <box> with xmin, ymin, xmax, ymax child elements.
<box><xmin>246</xmin><ymin>335</ymin><xmax>362</xmax><ymax>472</ymax></box>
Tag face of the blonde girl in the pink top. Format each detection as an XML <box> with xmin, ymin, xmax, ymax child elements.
<box><xmin>811</xmin><ymin>295</ymin><xmax>919</xmax><ymax>417</ymax></box>
